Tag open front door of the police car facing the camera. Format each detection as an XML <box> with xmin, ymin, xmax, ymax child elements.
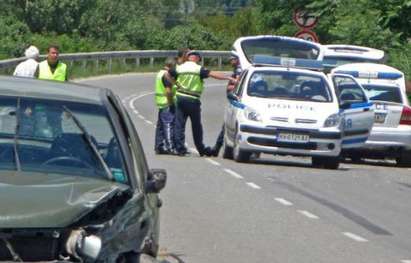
<box><xmin>332</xmin><ymin>74</ymin><xmax>374</xmax><ymax>149</ymax></box>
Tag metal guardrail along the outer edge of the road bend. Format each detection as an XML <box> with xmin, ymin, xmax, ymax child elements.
<box><xmin>0</xmin><ymin>50</ymin><xmax>230</xmax><ymax>73</ymax></box>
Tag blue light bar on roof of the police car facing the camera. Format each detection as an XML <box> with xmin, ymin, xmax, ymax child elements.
<box><xmin>253</xmin><ymin>55</ymin><xmax>324</xmax><ymax>71</ymax></box>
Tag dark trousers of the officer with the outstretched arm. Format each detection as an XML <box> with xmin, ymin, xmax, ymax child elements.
<box><xmin>175</xmin><ymin>96</ymin><xmax>205</xmax><ymax>153</ymax></box>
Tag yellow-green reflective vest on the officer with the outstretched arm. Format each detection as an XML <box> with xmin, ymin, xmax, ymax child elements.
<box><xmin>176</xmin><ymin>61</ymin><xmax>204</xmax><ymax>99</ymax></box>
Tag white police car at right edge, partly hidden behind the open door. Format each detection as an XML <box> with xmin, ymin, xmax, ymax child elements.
<box><xmin>332</xmin><ymin>63</ymin><xmax>411</xmax><ymax>167</ymax></box>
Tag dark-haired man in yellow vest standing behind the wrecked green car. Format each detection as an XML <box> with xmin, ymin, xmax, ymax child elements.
<box><xmin>35</xmin><ymin>45</ymin><xmax>68</xmax><ymax>81</ymax></box>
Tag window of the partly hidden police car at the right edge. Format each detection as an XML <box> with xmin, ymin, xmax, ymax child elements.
<box><xmin>362</xmin><ymin>84</ymin><xmax>402</xmax><ymax>103</ymax></box>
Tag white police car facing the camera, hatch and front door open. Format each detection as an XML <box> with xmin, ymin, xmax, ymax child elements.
<box><xmin>223</xmin><ymin>36</ymin><xmax>374</xmax><ymax>169</ymax></box>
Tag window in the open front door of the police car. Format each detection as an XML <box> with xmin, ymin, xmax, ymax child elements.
<box><xmin>333</xmin><ymin>76</ymin><xmax>368</xmax><ymax>105</ymax></box>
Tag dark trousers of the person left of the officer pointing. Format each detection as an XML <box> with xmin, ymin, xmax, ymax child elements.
<box><xmin>154</xmin><ymin>107</ymin><xmax>175</xmax><ymax>151</ymax></box>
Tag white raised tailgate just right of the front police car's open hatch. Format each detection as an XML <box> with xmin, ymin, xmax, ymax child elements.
<box><xmin>324</xmin><ymin>45</ymin><xmax>385</xmax><ymax>60</ymax></box>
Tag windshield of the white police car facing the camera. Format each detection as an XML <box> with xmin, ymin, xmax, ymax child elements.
<box><xmin>247</xmin><ymin>71</ymin><xmax>332</xmax><ymax>102</ymax></box>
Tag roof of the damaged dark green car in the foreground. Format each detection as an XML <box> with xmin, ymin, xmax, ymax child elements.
<box><xmin>0</xmin><ymin>76</ymin><xmax>102</xmax><ymax>104</ymax></box>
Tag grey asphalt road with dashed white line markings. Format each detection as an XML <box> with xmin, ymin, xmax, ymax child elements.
<box><xmin>84</xmin><ymin>74</ymin><xmax>411</xmax><ymax>263</ymax></box>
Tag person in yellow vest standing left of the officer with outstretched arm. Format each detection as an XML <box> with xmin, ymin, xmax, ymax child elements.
<box><xmin>154</xmin><ymin>58</ymin><xmax>176</xmax><ymax>154</ymax></box>
